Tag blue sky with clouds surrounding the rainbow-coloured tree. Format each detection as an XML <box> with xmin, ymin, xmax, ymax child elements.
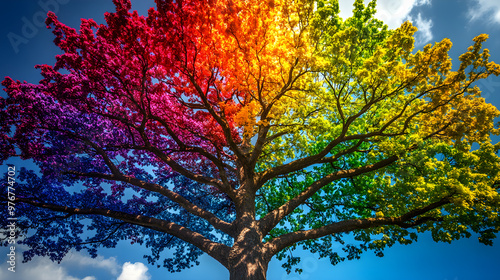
<box><xmin>0</xmin><ymin>0</ymin><xmax>500</xmax><ymax>280</ymax></box>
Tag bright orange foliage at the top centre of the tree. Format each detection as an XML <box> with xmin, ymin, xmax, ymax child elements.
<box><xmin>175</xmin><ymin>0</ymin><xmax>313</xmax><ymax>140</ymax></box>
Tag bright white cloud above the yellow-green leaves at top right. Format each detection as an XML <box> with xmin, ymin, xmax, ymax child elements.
<box><xmin>339</xmin><ymin>0</ymin><xmax>434</xmax><ymax>45</ymax></box>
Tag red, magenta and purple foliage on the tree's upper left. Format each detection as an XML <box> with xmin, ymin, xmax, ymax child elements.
<box><xmin>2</xmin><ymin>0</ymin><xmax>249</xmax><ymax>178</ymax></box>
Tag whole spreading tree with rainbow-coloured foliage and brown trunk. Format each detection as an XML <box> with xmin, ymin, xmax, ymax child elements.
<box><xmin>0</xmin><ymin>0</ymin><xmax>500</xmax><ymax>279</ymax></box>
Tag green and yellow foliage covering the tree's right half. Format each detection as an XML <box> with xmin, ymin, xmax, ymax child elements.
<box><xmin>257</xmin><ymin>1</ymin><xmax>500</xmax><ymax>272</ymax></box>
